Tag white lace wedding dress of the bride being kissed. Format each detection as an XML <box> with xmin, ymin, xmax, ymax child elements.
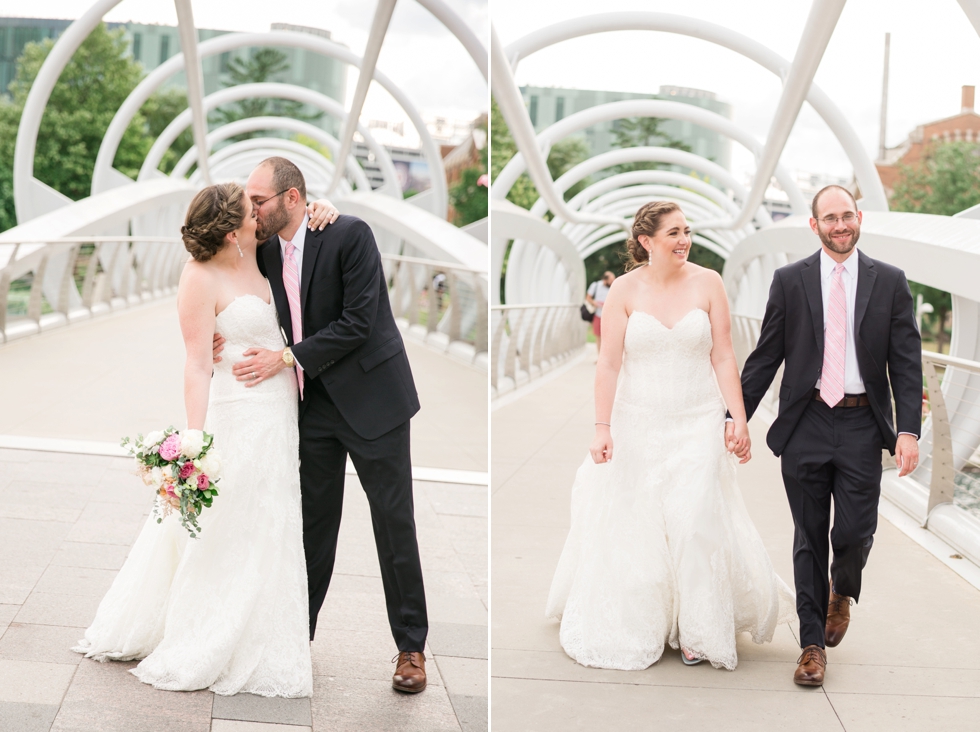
<box><xmin>74</xmin><ymin>295</ymin><xmax>313</xmax><ymax>697</ymax></box>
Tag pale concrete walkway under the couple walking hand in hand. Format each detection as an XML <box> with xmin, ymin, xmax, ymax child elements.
<box><xmin>491</xmin><ymin>350</ymin><xmax>980</xmax><ymax>732</ymax></box>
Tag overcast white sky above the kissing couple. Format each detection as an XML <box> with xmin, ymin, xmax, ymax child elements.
<box><xmin>0</xmin><ymin>0</ymin><xmax>490</xmax><ymax>120</ymax></box>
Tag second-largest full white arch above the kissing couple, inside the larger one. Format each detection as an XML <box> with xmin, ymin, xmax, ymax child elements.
<box><xmin>137</xmin><ymin>82</ymin><xmax>401</xmax><ymax>197</ymax></box>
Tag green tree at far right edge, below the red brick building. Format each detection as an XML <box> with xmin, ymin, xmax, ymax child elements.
<box><xmin>890</xmin><ymin>142</ymin><xmax>980</xmax><ymax>353</ymax></box>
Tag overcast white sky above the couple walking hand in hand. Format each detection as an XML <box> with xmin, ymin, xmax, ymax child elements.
<box><xmin>491</xmin><ymin>0</ymin><xmax>980</xmax><ymax>183</ymax></box>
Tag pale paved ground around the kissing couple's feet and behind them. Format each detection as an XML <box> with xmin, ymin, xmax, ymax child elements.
<box><xmin>0</xmin><ymin>296</ymin><xmax>489</xmax><ymax>732</ymax></box>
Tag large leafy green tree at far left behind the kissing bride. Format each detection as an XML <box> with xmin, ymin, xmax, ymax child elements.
<box><xmin>0</xmin><ymin>24</ymin><xmax>151</xmax><ymax>229</ymax></box>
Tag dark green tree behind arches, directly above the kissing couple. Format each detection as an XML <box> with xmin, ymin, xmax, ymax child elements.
<box><xmin>211</xmin><ymin>48</ymin><xmax>324</xmax><ymax>142</ymax></box>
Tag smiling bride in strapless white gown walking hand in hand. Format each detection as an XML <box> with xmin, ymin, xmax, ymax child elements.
<box><xmin>547</xmin><ymin>201</ymin><xmax>794</xmax><ymax>670</ymax></box>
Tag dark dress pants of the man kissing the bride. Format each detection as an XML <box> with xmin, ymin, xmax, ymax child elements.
<box><xmin>299</xmin><ymin>378</ymin><xmax>428</xmax><ymax>651</ymax></box>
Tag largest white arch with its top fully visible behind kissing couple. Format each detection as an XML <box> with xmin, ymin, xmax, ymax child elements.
<box><xmin>88</xmin><ymin>30</ymin><xmax>449</xmax><ymax>217</ymax></box>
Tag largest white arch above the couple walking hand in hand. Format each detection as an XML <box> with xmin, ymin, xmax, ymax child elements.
<box><xmin>506</xmin><ymin>11</ymin><xmax>892</xmax><ymax>211</ymax></box>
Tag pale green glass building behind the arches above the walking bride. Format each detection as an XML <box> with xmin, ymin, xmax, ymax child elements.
<box><xmin>521</xmin><ymin>86</ymin><xmax>732</xmax><ymax>169</ymax></box>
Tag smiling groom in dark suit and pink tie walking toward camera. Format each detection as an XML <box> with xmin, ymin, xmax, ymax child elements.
<box><xmin>728</xmin><ymin>186</ymin><xmax>922</xmax><ymax>686</ymax></box>
